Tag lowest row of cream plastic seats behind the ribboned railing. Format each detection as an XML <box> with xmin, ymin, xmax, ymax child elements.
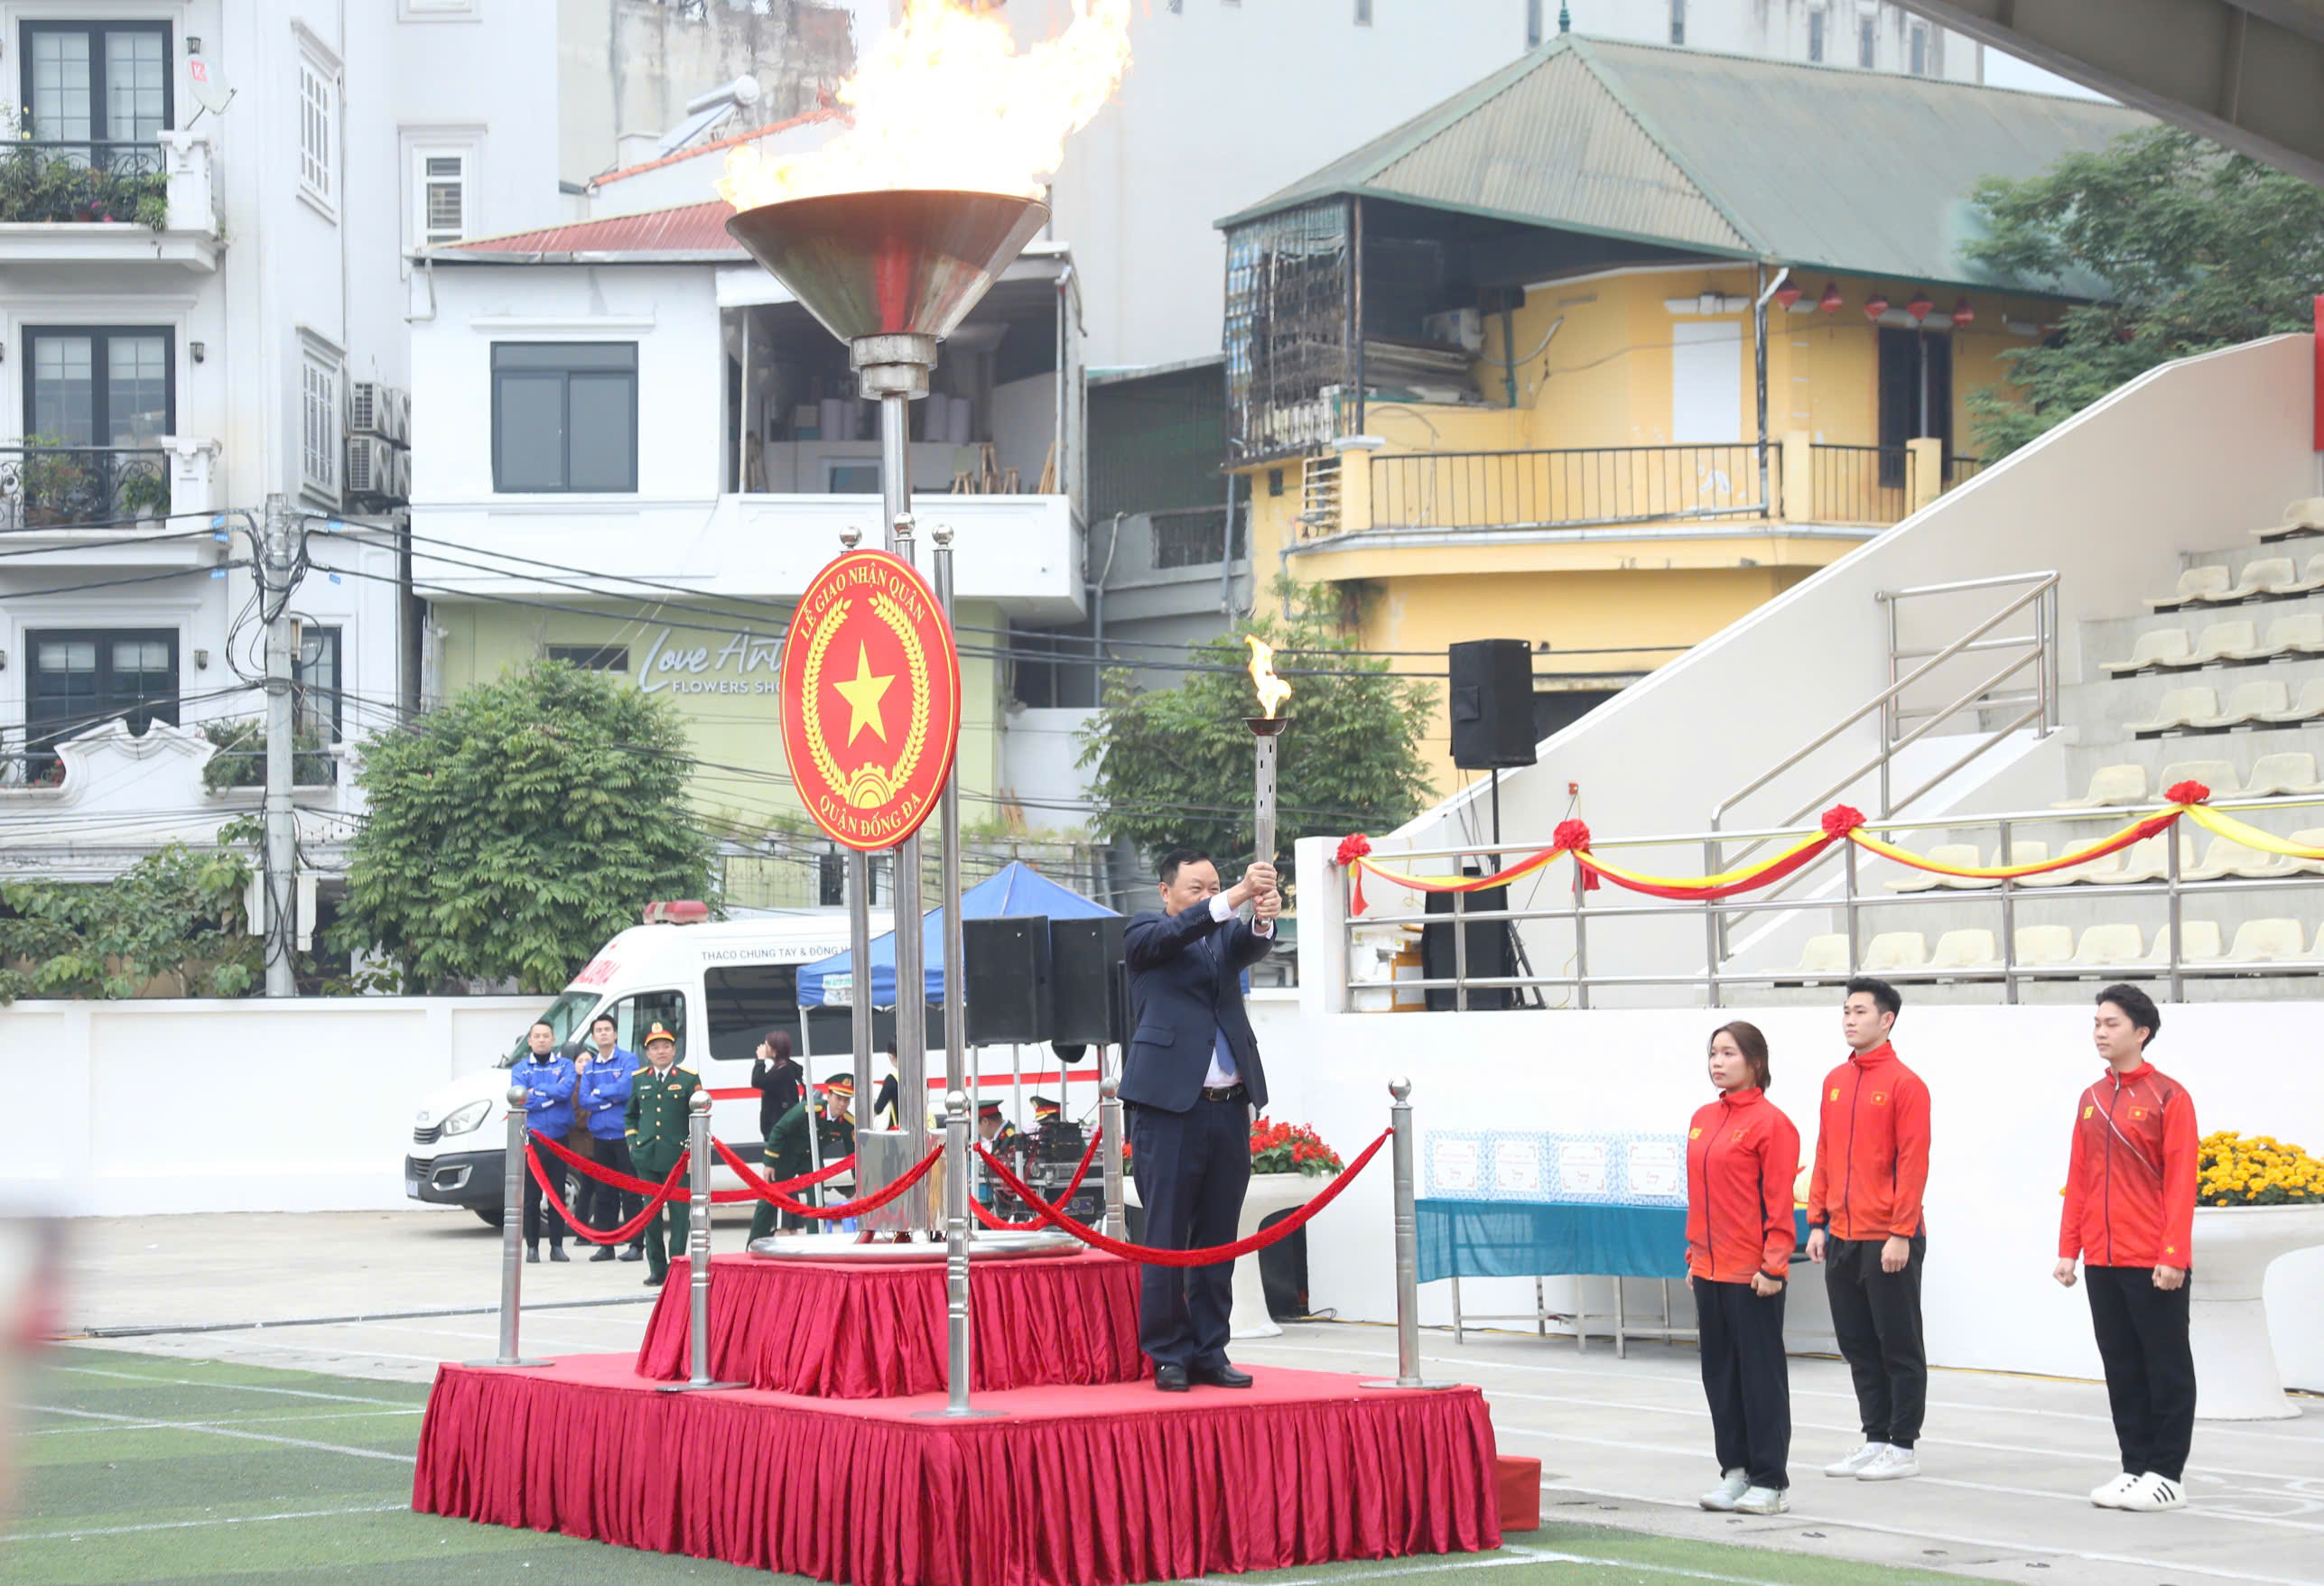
<box><xmin>1782</xmin><ymin>920</ymin><xmax>2324</xmax><ymax>980</ymax></box>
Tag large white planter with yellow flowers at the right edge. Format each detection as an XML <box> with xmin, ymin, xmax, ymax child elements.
<box><xmin>2187</xmin><ymin>1128</ymin><xmax>2324</xmax><ymax>1421</ymax></box>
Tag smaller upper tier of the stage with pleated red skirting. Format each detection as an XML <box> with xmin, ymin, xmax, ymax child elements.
<box><xmin>637</xmin><ymin>1254</ymin><xmax>1146</xmax><ymax>1398</ymax></box>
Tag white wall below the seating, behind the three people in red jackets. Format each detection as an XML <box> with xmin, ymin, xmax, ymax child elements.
<box><xmin>1252</xmin><ymin>987</ymin><xmax>2324</xmax><ymax>1391</ymax></box>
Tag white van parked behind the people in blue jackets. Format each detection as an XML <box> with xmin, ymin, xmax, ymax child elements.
<box><xmin>404</xmin><ymin>910</ymin><xmax>892</xmax><ymax>1229</ymax></box>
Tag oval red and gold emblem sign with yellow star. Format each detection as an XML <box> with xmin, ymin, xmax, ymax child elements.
<box><xmin>781</xmin><ymin>551</ymin><xmax>960</xmax><ymax>852</ymax></box>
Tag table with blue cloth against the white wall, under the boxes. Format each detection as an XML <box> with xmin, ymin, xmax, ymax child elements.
<box><xmin>1413</xmin><ymin>1198</ymin><xmax>1808</xmax><ymax>1356</ymax></box>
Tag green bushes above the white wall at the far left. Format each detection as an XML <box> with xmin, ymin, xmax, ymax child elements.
<box><xmin>0</xmin><ymin>843</ymin><xmax>258</xmax><ymax>1006</ymax></box>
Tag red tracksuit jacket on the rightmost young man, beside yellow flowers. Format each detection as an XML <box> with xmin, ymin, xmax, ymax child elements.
<box><xmin>2057</xmin><ymin>1063</ymin><xmax>2203</xmax><ymax>1268</ymax></box>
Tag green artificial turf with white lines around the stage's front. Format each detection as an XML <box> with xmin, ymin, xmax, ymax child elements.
<box><xmin>0</xmin><ymin>1349</ymin><xmax>1959</xmax><ymax>1586</ymax></box>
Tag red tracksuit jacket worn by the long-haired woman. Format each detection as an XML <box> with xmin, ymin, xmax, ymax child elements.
<box><xmin>1687</xmin><ymin>1084</ymin><xmax>1799</xmax><ymax>1285</ymax></box>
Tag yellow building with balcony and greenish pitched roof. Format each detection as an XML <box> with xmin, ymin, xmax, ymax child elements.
<box><xmin>1220</xmin><ymin>35</ymin><xmax>2145</xmax><ymax>794</ymax></box>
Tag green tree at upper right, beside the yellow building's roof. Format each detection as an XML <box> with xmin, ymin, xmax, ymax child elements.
<box><xmin>1961</xmin><ymin>127</ymin><xmax>2324</xmax><ymax>459</ymax></box>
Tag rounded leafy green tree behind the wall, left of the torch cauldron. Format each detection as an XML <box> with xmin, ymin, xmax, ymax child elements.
<box><xmin>332</xmin><ymin>662</ymin><xmax>711</xmax><ymax>991</ymax></box>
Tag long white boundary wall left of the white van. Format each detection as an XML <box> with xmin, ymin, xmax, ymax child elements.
<box><xmin>0</xmin><ymin>997</ymin><xmax>535</xmax><ymax>1217</ymax></box>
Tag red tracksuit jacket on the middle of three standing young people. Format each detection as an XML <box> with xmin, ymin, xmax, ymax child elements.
<box><xmin>1808</xmin><ymin>1040</ymin><xmax>1929</xmax><ymax>1240</ymax></box>
